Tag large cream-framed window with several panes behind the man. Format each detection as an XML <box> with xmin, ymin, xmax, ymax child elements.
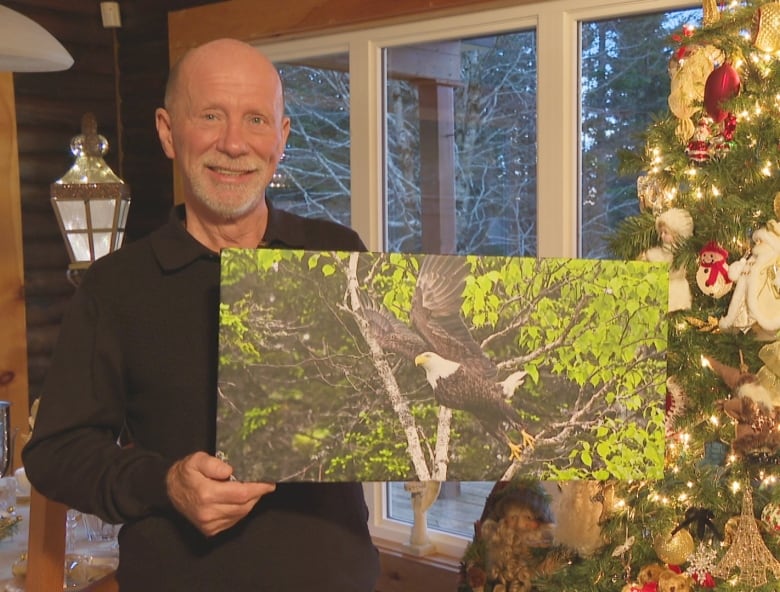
<box><xmin>262</xmin><ymin>0</ymin><xmax>701</xmax><ymax>557</ymax></box>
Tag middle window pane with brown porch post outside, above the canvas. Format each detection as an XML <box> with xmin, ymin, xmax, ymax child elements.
<box><xmin>386</xmin><ymin>31</ymin><xmax>536</xmax><ymax>255</ymax></box>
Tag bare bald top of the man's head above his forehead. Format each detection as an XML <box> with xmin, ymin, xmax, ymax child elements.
<box><xmin>165</xmin><ymin>39</ymin><xmax>284</xmax><ymax>113</ymax></box>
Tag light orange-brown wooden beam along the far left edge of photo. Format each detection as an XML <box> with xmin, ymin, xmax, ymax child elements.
<box><xmin>0</xmin><ymin>72</ymin><xmax>29</xmax><ymax>468</ymax></box>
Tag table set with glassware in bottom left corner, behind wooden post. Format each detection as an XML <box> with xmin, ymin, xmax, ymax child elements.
<box><xmin>0</xmin><ymin>498</ymin><xmax>119</xmax><ymax>592</ymax></box>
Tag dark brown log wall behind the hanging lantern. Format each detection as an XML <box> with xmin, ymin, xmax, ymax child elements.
<box><xmin>5</xmin><ymin>0</ymin><xmax>216</xmax><ymax>400</ymax></box>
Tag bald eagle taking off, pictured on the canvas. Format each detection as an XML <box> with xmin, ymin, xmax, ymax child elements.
<box><xmin>363</xmin><ymin>255</ymin><xmax>534</xmax><ymax>458</ymax></box>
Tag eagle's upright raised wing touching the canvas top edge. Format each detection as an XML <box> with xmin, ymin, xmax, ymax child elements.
<box><xmin>410</xmin><ymin>255</ymin><xmax>497</xmax><ymax>378</ymax></box>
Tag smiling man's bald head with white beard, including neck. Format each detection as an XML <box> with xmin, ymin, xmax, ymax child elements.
<box><xmin>155</xmin><ymin>39</ymin><xmax>290</xmax><ymax>251</ymax></box>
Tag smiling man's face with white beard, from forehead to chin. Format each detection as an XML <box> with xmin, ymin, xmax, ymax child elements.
<box><xmin>157</xmin><ymin>49</ymin><xmax>290</xmax><ymax>219</ymax></box>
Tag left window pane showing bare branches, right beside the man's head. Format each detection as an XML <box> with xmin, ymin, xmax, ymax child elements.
<box><xmin>268</xmin><ymin>54</ymin><xmax>350</xmax><ymax>225</ymax></box>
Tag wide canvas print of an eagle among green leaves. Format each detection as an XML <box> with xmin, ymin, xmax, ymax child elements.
<box><xmin>217</xmin><ymin>249</ymin><xmax>668</xmax><ymax>482</ymax></box>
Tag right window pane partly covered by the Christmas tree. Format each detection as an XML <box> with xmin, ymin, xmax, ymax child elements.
<box><xmin>580</xmin><ymin>9</ymin><xmax>701</xmax><ymax>259</ymax></box>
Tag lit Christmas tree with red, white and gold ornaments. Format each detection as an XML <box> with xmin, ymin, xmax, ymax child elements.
<box><xmin>462</xmin><ymin>0</ymin><xmax>780</xmax><ymax>592</ymax></box>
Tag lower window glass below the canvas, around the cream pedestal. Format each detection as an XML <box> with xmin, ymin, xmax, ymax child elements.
<box><xmin>385</xmin><ymin>481</ymin><xmax>495</xmax><ymax>539</ymax></box>
